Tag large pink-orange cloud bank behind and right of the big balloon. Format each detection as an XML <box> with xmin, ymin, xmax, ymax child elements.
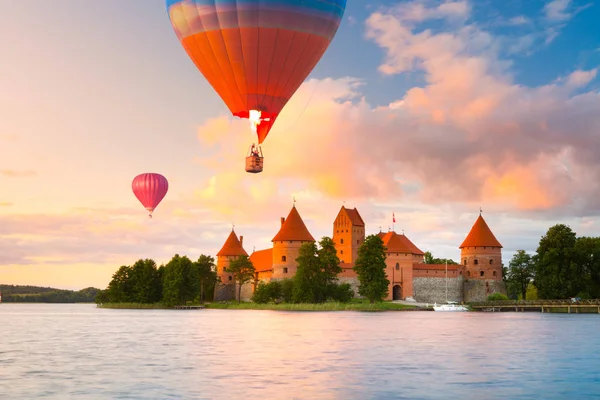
<box><xmin>193</xmin><ymin>1</ymin><xmax>600</xmax><ymax>222</ymax></box>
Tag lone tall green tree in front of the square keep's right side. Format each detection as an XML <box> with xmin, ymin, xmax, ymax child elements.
<box><xmin>354</xmin><ymin>235</ymin><xmax>390</xmax><ymax>303</ymax></box>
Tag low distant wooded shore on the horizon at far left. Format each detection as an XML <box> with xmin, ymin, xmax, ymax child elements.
<box><xmin>0</xmin><ymin>285</ymin><xmax>99</xmax><ymax>303</ymax></box>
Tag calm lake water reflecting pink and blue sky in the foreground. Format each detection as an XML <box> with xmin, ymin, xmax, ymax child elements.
<box><xmin>0</xmin><ymin>303</ymin><xmax>600</xmax><ymax>400</ymax></box>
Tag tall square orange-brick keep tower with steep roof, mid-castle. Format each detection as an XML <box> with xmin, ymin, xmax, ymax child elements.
<box><xmin>333</xmin><ymin>206</ymin><xmax>365</xmax><ymax>264</ymax></box>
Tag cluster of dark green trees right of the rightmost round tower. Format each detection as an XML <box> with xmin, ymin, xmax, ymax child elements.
<box><xmin>504</xmin><ymin>224</ymin><xmax>600</xmax><ymax>300</ymax></box>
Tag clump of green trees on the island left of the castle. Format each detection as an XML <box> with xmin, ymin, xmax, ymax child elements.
<box><xmin>96</xmin><ymin>254</ymin><xmax>217</xmax><ymax>306</ymax></box>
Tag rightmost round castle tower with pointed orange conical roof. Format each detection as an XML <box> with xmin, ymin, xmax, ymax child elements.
<box><xmin>459</xmin><ymin>213</ymin><xmax>506</xmax><ymax>301</ymax></box>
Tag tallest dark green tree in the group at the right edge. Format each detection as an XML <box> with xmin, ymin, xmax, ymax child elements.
<box><xmin>534</xmin><ymin>224</ymin><xmax>581</xmax><ymax>299</ymax></box>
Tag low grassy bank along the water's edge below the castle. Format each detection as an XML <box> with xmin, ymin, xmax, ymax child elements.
<box><xmin>98</xmin><ymin>301</ymin><xmax>424</xmax><ymax>311</ymax></box>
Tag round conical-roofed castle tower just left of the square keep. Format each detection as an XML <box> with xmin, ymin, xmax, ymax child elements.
<box><xmin>271</xmin><ymin>205</ymin><xmax>315</xmax><ymax>280</ymax></box>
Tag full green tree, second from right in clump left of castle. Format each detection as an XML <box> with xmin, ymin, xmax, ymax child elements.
<box><xmin>163</xmin><ymin>254</ymin><xmax>200</xmax><ymax>306</ymax></box>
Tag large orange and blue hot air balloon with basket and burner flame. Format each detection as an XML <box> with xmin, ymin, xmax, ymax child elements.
<box><xmin>166</xmin><ymin>0</ymin><xmax>346</xmax><ymax>172</ymax></box>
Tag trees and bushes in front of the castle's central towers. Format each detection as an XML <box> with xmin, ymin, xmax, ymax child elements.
<box><xmin>252</xmin><ymin>235</ymin><xmax>389</xmax><ymax>303</ymax></box>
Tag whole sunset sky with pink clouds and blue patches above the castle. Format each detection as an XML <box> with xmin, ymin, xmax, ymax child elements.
<box><xmin>0</xmin><ymin>0</ymin><xmax>600</xmax><ymax>289</ymax></box>
